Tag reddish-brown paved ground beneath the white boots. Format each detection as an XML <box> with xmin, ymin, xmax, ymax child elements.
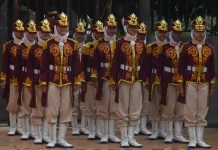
<box><xmin>0</xmin><ymin>127</ymin><xmax>218</xmax><ymax>150</ymax></box>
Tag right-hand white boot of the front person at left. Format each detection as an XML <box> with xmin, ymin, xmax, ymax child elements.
<box><xmin>57</xmin><ymin>123</ymin><xmax>73</xmax><ymax>148</ymax></box>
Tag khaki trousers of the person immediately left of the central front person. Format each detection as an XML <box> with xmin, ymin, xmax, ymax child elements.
<box><xmin>96</xmin><ymin>80</ymin><xmax>117</xmax><ymax>120</ymax></box>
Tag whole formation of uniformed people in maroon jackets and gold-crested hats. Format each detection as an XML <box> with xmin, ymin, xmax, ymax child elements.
<box><xmin>1</xmin><ymin>13</ymin><xmax>215</xmax><ymax>148</ymax></box>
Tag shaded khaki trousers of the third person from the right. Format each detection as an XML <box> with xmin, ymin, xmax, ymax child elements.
<box><xmin>149</xmin><ymin>85</ymin><xmax>163</xmax><ymax>121</ymax></box>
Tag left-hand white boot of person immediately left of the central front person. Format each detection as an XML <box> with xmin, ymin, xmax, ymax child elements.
<box><xmin>100</xmin><ymin>120</ymin><xmax>108</xmax><ymax>144</ymax></box>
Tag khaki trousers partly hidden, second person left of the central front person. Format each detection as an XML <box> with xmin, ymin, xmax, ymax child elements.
<box><xmin>85</xmin><ymin>83</ymin><xmax>97</xmax><ymax>118</ymax></box>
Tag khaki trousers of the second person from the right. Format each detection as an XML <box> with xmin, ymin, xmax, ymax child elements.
<box><xmin>163</xmin><ymin>84</ymin><xmax>184</xmax><ymax>121</ymax></box>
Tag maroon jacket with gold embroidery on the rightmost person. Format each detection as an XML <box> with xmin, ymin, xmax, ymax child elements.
<box><xmin>177</xmin><ymin>41</ymin><xmax>215</xmax><ymax>101</ymax></box>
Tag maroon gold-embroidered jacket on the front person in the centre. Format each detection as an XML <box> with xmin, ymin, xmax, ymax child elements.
<box><xmin>111</xmin><ymin>39</ymin><xmax>150</xmax><ymax>102</ymax></box>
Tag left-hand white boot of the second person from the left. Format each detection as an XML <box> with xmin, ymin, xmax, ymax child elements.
<box><xmin>20</xmin><ymin>117</ymin><xmax>30</xmax><ymax>140</ymax></box>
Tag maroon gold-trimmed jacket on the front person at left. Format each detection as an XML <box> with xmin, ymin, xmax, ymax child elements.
<box><xmin>39</xmin><ymin>38</ymin><xmax>82</xmax><ymax>87</ymax></box>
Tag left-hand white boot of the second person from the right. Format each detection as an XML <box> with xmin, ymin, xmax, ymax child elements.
<box><xmin>164</xmin><ymin>121</ymin><xmax>173</xmax><ymax>144</ymax></box>
